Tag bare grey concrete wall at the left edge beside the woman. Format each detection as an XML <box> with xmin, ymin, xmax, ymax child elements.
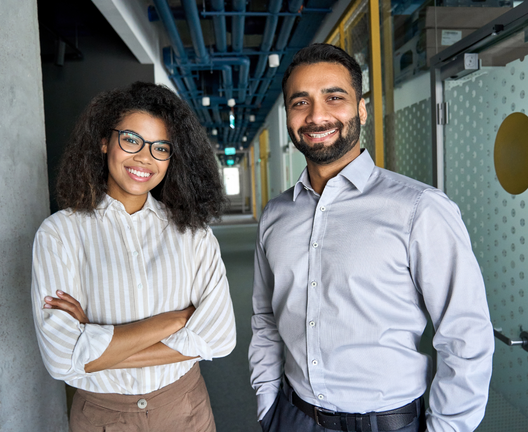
<box><xmin>0</xmin><ymin>0</ymin><xmax>67</xmax><ymax>432</ymax></box>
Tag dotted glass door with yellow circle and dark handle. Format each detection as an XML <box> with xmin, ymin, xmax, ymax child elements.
<box><xmin>431</xmin><ymin>2</ymin><xmax>528</xmax><ymax>432</ymax></box>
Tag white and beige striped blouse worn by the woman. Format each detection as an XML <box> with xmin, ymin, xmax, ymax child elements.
<box><xmin>32</xmin><ymin>194</ymin><xmax>235</xmax><ymax>394</ymax></box>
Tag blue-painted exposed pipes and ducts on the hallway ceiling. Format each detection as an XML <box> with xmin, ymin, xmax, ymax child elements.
<box><xmin>149</xmin><ymin>0</ymin><xmax>335</xmax><ymax>153</ymax></box>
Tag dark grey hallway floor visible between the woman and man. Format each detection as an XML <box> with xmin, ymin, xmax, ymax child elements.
<box><xmin>200</xmin><ymin>221</ymin><xmax>261</xmax><ymax>432</ymax></box>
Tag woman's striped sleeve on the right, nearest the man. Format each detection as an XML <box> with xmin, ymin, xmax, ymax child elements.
<box><xmin>161</xmin><ymin>228</ymin><xmax>236</xmax><ymax>360</ymax></box>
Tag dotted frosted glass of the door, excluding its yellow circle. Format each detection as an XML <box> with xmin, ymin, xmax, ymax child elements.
<box><xmin>445</xmin><ymin>59</ymin><xmax>528</xmax><ymax>422</ymax></box>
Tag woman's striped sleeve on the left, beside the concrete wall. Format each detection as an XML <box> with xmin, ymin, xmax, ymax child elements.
<box><xmin>31</xmin><ymin>228</ymin><xmax>114</xmax><ymax>381</ymax></box>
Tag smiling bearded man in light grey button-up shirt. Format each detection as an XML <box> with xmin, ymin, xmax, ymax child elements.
<box><xmin>249</xmin><ymin>44</ymin><xmax>494</xmax><ymax>432</ymax></box>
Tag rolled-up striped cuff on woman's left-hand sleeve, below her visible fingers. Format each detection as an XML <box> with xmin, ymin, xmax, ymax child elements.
<box><xmin>72</xmin><ymin>324</ymin><xmax>114</xmax><ymax>375</ymax></box>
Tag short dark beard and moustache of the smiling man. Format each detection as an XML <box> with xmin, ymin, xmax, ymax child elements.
<box><xmin>288</xmin><ymin>114</ymin><xmax>361</xmax><ymax>165</ymax></box>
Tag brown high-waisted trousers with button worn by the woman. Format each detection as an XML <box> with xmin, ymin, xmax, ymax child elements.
<box><xmin>70</xmin><ymin>363</ymin><xmax>216</xmax><ymax>432</ymax></box>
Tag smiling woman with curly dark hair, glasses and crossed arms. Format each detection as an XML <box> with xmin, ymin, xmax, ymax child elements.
<box><xmin>32</xmin><ymin>83</ymin><xmax>235</xmax><ymax>432</ymax></box>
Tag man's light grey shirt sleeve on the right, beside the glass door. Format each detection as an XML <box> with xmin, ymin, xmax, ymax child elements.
<box><xmin>409</xmin><ymin>189</ymin><xmax>494</xmax><ymax>432</ymax></box>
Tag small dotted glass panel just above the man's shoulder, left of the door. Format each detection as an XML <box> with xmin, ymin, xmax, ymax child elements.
<box><xmin>386</xmin><ymin>98</ymin><xmax>433</xmax><ymax>184</ymax></box>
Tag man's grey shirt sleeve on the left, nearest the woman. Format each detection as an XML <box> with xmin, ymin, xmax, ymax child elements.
<box><xmin>249</xmin><ymin>217</ymin><xmax>284</xmax><ymax>420</ymax></box>
